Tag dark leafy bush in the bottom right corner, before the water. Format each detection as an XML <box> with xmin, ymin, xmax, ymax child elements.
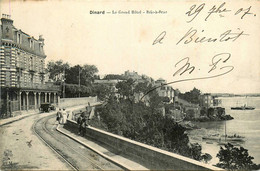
<box><xmin>216</xmin><ymin>143</ymin><xmax>260</xmax><ymax>170</ymax></box>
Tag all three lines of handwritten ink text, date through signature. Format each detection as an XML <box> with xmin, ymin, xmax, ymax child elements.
<box><xmin>146</xmin><ymin>2</ymin><xmax>256</xmax><ymax>99</ymax></box>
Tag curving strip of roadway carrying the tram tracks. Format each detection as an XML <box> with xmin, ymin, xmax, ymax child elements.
<box><xmin>34</xmin><ymin>115</ymin><xmax>122</xmax><ymax>170</ymax></box>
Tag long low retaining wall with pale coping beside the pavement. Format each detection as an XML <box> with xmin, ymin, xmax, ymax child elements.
<box><xmin>64</xmin><ymin>120</ymin><xmax>221</xmax><ymax>170</ymax></box>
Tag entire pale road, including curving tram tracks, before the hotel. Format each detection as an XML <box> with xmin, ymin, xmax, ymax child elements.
<box><xmin>0</xmin><ymin>112</ymin><xmax>122</xmax><ymax>170</ymax></box>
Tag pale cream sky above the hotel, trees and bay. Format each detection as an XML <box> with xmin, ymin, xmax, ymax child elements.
<box><xmin>0</xmin><ymin>0</ymin><xmax>260</xmax><ymax>93</ymax></box>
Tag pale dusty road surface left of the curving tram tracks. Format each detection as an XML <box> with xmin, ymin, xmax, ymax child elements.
<box><xmin>0</xmin><ymin>112</ymin><xmax>71</xmax><ymax>170</ymax></box>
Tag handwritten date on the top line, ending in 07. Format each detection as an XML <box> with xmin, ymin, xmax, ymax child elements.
<box><xmin>185</xmin><ymin>2</ymin><xmax>256</xmax><ymax>23</ymax></box>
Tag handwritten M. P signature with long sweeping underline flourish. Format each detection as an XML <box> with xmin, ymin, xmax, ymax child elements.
<box><xmin>140</xmin><ymin>53</ymin><xmax>234</xmax><ymax>100</ymax></box>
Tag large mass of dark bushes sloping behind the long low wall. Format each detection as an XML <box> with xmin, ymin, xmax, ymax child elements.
<box><xmin>97</xmin><ymin>86</ymin><xmax>203</xmax><ymax>160</ymax></box>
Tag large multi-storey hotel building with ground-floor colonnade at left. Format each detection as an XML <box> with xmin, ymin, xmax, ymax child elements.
<box><xmin>0</xmin><ymin>14</ymin><xmax>60</xmax><ymax>117</ymax></box>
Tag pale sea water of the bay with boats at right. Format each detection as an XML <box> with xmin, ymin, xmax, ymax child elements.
<box><xmin>188</xmin><ymin>97</ymin><xmax>260</xmax><ymax>164</ymax></box>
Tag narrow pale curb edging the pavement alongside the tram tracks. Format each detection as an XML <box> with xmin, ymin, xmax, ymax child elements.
<box><xmin>56</xmin><ymin>125</ymin><xmax>135</xmax><ymax>170</ymax></box>
